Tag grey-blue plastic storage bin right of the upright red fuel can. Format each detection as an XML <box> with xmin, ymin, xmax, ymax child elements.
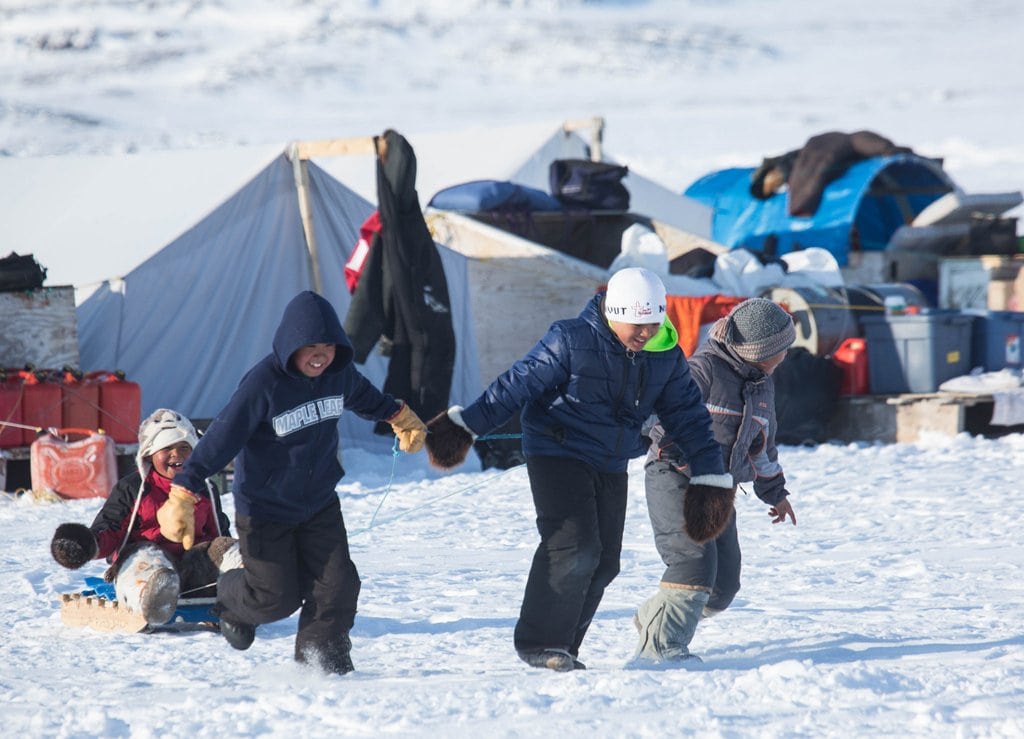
<box><xmin>861</xmin><ymin>310</ymin><xmax>974</xmax><ymax>395</ymax></box>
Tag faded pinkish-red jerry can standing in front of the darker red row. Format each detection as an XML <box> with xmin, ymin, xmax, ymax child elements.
<box><xmin>29</xmin><ymin>429</ymin><xmax>118</xmax><ymax>497</ymax></box>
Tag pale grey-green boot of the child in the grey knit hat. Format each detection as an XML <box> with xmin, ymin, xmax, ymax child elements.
<box><xmin>633</xmin><ymin>585</ymin><xmax>711</xmax><ymax>664</ymax></box>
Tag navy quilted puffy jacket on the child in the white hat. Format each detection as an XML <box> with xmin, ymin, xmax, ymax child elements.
<box><xmin>462</xmin><ymin>294</ymin><xmax>724</xmax><ymax>475</ymax></box>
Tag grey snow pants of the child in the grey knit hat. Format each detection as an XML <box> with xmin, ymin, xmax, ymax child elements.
<box><xmin>644</xmin><ymin>461</ymin><xmax>740</xmax><ymax>611</ymax></box>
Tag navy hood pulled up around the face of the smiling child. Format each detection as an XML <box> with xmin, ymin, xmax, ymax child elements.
<box><xmin>273</xmin><ymin>290</ymin><xmax>352</xmax><ymax>377</ymax></box>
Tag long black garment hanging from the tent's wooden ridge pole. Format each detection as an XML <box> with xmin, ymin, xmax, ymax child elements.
<box><xmin>345</xmin><ymin>130</ymin><xmax>455</xmax><ymax>425</ymax></box>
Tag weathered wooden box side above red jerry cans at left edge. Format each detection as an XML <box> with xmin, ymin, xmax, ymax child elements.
<box><xmin>0</xmin><ymin>286</ymin><xmax>80</xmax><ymax>367</ymax></box>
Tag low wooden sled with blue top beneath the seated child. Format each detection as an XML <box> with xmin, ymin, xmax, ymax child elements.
<box><xmin>60</xmin><ymin>577</ymin><xmax>219</xmax><ymax>634</ymax></box>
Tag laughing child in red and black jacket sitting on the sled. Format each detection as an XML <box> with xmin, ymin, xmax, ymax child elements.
<box><xmin>50</xmin><ymin>408</ymin><xmax>235</xmax><ymax>625</ymax></box>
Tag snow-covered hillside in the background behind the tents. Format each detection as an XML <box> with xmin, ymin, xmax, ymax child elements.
<box><xmin>0</xmin><ymin>0</ymin><xmax>1024</xmax><ymax>197</ymax></box>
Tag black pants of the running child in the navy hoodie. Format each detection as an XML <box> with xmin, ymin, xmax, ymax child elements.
<box><xmin>217</xmin><ymin>498</ymin><xmax>360</xmax><ymax>669</ymax></box>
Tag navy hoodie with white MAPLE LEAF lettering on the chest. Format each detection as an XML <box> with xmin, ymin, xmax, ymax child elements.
<box><xmin>174</xmin><ymin>291</ymin><xmax>400</xmax><ymax>523</ymax></box>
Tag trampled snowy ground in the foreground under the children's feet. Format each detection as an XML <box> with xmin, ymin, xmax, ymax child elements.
<box><xmin>6</xmin><ymin>435</ymin><xmax>1024</xmax><ymax>738</ymax></box>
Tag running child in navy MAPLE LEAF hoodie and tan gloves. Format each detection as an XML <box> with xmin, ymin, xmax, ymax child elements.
<box><xmin>158</xmin><ymin>291</ymin><xmax>426</xmax><ymax>673</ymax></box>
